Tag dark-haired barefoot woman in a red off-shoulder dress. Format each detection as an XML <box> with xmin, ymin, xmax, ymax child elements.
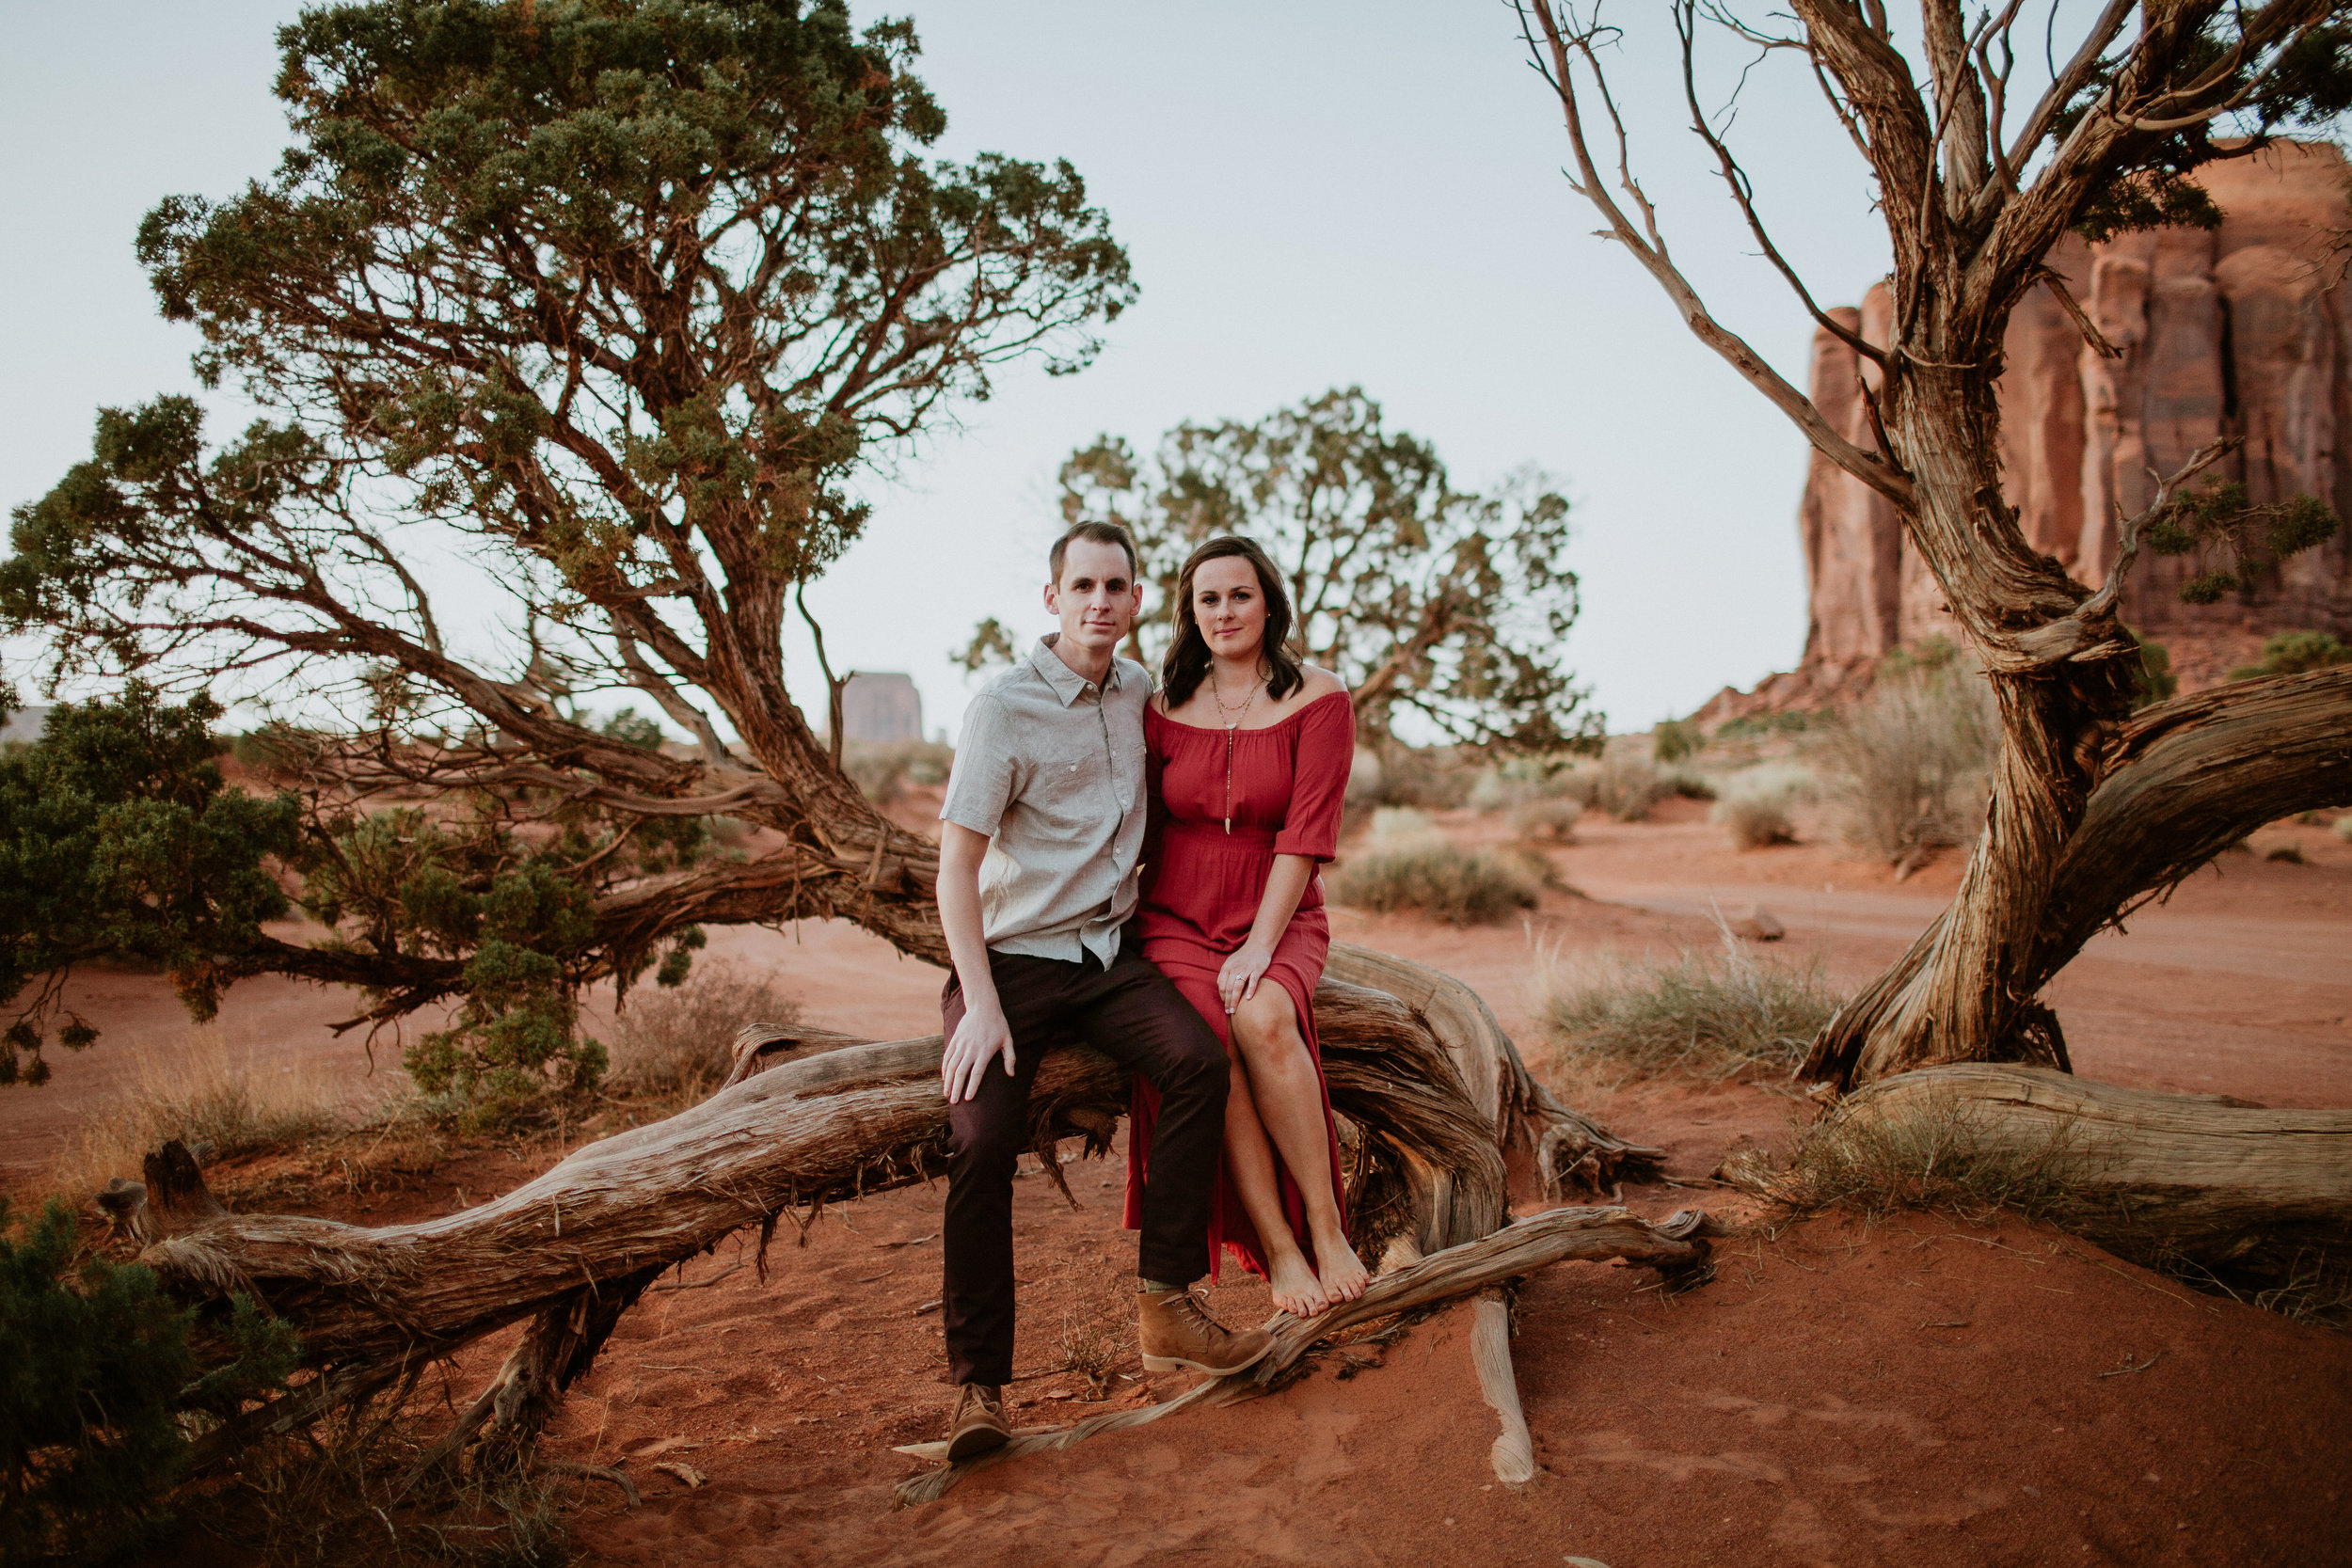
<box><xmin>1127</xmin><ymin>533</ymin><xmax>1369</xmax><ymax>1317</ymax></box>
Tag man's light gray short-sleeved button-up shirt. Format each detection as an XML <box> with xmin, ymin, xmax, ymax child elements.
<box><xmin>939</xmin><ymin>637</ymin><xmax>1152</xmax><ymax>966</ymax></box>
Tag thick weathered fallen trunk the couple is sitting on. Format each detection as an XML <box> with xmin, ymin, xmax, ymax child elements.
<box><xmin>141</xmin><ymin>961</ymin><xmax>1630</xmax><ymax>1458</ymax></box>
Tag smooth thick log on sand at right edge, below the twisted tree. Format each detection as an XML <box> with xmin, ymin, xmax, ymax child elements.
<box><xmin>1726</xmin><ymin>1063</ymin><xmax>2352</xmax><ymax>1284</ymax></box>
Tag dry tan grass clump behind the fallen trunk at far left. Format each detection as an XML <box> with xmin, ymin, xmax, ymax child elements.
<box><xmin>50</xmin><ymin>1025</ymin><xmax>367</xmax><ymax>1192</ymax></box>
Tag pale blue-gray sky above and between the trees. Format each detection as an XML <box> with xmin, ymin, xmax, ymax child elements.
<box><xmin>0</xmin><ymin>0</ymin><xmax>1884</xmax><ymax>734</ymax></box>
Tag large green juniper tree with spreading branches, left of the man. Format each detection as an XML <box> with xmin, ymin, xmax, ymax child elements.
<box><xmin>0</xmin><ymin>0</ymin><xmax>1134</xmax><ymax>1098</ymax></box>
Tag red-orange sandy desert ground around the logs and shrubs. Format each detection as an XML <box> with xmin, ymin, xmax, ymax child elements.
<box><xmin>0</xmin><ymin>801</ymin><xmax>2352</xmax><ymax>1568</ymax></box>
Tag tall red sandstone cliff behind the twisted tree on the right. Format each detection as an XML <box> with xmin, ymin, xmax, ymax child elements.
<box><xmin>1800</xmin><ymin>146</ymin><xmax>2352</xmax><ymax>689</ymax></box>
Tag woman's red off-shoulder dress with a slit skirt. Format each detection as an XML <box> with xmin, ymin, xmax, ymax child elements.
<box><xmin>1127</xmin><ymin>691</ymin><xmax>1355</xmax><ymax>1279</ymax></box>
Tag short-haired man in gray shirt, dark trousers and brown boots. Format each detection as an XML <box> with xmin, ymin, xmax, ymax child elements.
<box><xmin>939</xmin><ymin>522</ymin><xmax>1273</xmax><ymax>1460</ymax></box>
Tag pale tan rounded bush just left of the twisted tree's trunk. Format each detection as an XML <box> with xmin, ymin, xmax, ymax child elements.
<box><xmin>1814</xmin><ymin>663</ymin><xmax>1999</xmax><ymax>863</ymax></box>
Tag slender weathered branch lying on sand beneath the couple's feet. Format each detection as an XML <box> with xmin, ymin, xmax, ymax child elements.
<box><xmin>898</xmin><ymin>1209</ymin><xmax>1724</xmax><ymax>1507</ymax></box>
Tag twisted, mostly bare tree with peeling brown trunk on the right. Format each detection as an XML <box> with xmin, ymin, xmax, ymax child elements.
<box><xmin>1518</xmin><ymin>0</ymin><xmax>2352</xmax><ymax>1084</ymax></box>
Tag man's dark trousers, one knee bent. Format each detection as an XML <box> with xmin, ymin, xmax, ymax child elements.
<box><xmin>941</xmin><ymin>928</ymin><xmax>1232</xmax><ymax>1385</ymax></box>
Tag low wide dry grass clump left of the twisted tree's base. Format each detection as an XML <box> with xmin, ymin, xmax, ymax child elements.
<box><xmin>1534</xmin><ymin>936</ymin><xmax>1839</xmax><ymax>1079</ymax></box>
